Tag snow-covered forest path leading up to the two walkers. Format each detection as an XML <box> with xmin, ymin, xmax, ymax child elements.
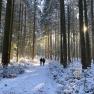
<box><xmin>0</xmin><ymin>64</ymin><xmax>56</xmax><ymax>94</ymax></box>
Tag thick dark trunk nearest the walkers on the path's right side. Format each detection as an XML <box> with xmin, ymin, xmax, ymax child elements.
<box><xmin>60</xmin><ymin>0</ymin><xmax>67</xmax><ymax>68</ymax></box>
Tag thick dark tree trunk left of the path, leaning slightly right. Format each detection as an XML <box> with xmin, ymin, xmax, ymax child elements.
<box><xmin>2</xmin><ymin>0</ymin><xmax>12</xmax><ymax>67</ymax></box>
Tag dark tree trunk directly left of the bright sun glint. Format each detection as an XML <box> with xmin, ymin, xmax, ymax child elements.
<box><xmin>79</xmin><ymin>0</ymin><xmax>87</xmax><ymax>69</ymax></box>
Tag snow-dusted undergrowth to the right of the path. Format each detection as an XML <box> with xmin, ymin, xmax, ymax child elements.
<box><xmin>49</xmin><ymin>61</ymin><xmax>94</xmax><ymax>94</ymax></box>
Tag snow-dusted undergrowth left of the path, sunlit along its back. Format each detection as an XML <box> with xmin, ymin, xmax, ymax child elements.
<box><xmin>0</xmin><ymin>59</ymin><xmax>32</xmax><ymax>78</ymax></box>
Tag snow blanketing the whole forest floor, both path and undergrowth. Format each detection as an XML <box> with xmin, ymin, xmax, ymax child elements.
<box><xmin>0</xmin><ymin>58</ymin><xmax>94</xmax><ymax>94</ymax></box>
